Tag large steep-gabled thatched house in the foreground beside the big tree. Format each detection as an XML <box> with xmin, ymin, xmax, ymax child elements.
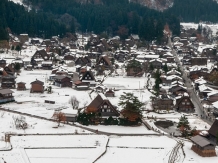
<box><xmin>85</xmin><ymin>93</ymin><xmax>119</xmax><ymax>117</ymax></box>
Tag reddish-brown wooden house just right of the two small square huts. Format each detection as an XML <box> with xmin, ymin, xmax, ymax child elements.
<box><xmin>54</xmin><ymin>75</ymin><xmax>72</xmax><ymax>87</ymax></box>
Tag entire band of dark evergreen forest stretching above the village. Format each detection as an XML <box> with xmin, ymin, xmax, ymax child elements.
<box><xmin>0</xmin><ymin>0</ymin><xmax>218</xmax><ymax>40</ymax></box>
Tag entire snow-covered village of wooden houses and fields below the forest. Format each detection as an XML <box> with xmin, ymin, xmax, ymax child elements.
<box><xmin>0</xmin><ymin>23</ymin><xmax>218</xmax><ymax>163</ymax></box>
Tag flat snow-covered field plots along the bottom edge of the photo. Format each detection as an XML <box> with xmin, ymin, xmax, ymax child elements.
<box><xmin>0</xmin><ymin>135</ymin><xmax>218</xmax><ymax>163</ymax></box>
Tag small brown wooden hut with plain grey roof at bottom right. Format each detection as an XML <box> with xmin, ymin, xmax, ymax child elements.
<box><xmin>191</xmin><ymin>135</ymin><xmax>216</xmax><ymax>157</ymax></box>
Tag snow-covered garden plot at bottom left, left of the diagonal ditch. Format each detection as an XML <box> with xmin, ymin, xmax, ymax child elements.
<box><xmin>0</xmin><ymin>135</ymin><xmax>108</xmax><ymax>163</ymax></box>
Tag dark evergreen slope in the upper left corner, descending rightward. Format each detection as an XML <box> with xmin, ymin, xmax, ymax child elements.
<box><xmin>0</xmin><ymin>0</ymin><xmax>66</xmax><ymax>40</ymax></box>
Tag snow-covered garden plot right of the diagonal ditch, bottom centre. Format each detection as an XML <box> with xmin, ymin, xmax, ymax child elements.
<box><xmin>97</xmin><ymin>136</ymin><xmax>176</xmax><ymax>163</ymax></box>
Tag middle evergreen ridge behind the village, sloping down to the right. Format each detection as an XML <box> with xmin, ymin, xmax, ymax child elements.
<box><xmin>21</xmin><ymin>0</ymin><xmax>179</xmax><ymax>40</ymax></box>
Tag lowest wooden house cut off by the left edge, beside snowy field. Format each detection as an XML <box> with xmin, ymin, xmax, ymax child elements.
<box><xmin>0</xmin><ymin>89</ymin><xmax>14</xmax><ymax>104</ymax></box>
